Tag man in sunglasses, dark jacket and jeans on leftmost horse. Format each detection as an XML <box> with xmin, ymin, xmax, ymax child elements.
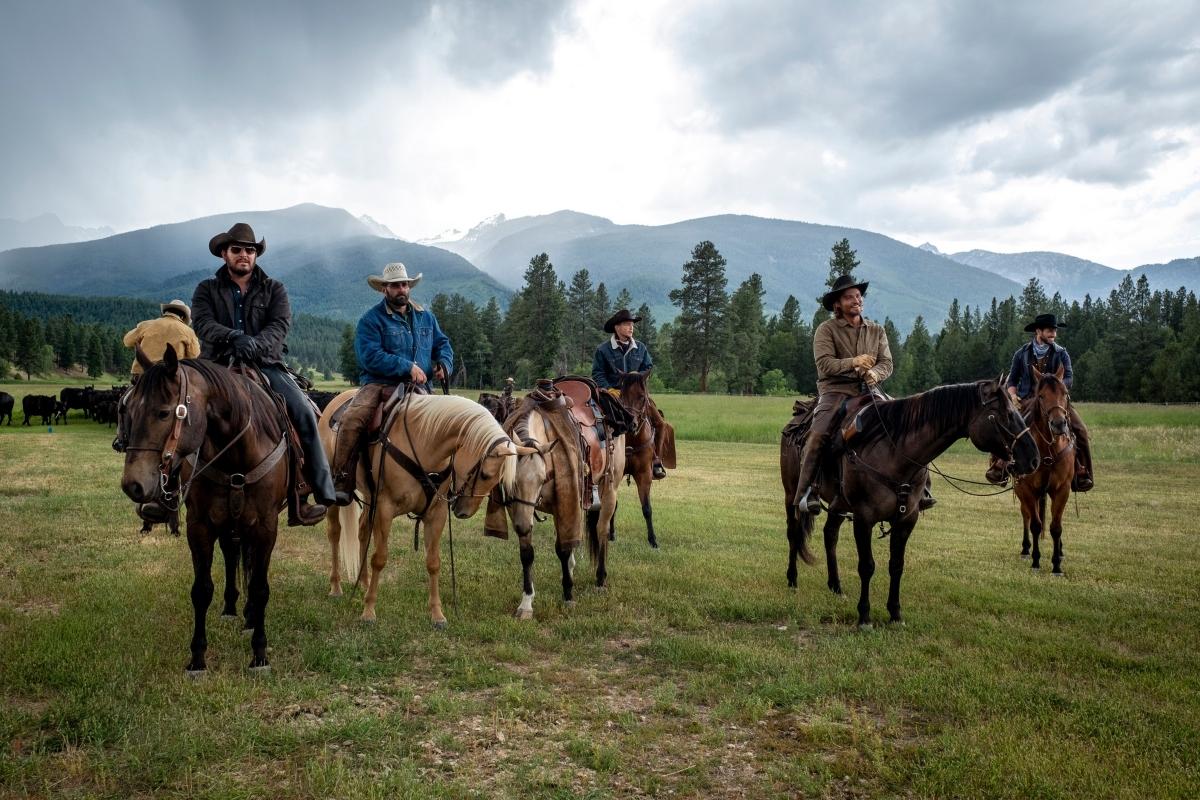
<box><xmin>192</xmin><ymin>222</ymin><xmax>334</xmax><ymax>525</ymax></box>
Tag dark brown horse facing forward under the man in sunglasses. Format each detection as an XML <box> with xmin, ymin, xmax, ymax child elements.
<box><xmin>121</xmin><ymin>345</ymin><xmax>288</xmax><ymax>675</ymax></box>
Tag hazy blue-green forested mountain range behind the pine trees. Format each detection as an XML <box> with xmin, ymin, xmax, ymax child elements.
<box><xmin>0</xmin><ymin>204</ymin><xmax>1200</xmax><ymax>330</ymax></box>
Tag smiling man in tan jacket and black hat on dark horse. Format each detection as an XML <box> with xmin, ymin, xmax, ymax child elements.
<box><xmin>796</xmin><ymin>275</ymin><xmax>937</xmax><ymax>515</ymax></box>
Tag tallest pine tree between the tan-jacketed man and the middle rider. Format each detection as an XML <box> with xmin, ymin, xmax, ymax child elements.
<box><xmin>670</xmin><ymin>241</ymin><xmax>728</xmax><ymax>392</ymax></box>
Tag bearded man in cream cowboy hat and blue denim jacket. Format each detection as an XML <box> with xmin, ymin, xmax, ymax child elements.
<box><xmin>334</xmin><ymin>261</ymin><xmax>454</xmax><ymax>505</ymax></box>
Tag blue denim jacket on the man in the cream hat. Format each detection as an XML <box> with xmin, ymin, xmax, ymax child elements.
<box><xmin>354</xmin><ymin>300</ymin><xmax>454</xmax><ymax>385</ymax></box>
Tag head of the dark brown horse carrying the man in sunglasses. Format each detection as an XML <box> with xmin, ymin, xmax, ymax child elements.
<box><xmin>119</xmin><ymin>344</ymin><xmax>205</xmax><ymax>503</ymax></box>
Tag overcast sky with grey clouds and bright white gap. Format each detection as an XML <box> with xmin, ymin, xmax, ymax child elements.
<box><xmin>0</xmin><ymin>0</ymin><xmax>1200</xmax><ymax>267</ymax></box>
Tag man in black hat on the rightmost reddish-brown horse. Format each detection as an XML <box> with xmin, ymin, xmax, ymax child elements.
<box><xmin>985</xmin><ymin>314</ymin><xmax>1094</xmax><ymax>492</ymax></box>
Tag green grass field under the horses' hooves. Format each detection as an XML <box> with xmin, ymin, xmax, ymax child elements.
<box><xmin>0</xmin><ymin>383</ymin><xmax>1200</xmax><ymax>798</ymax></box>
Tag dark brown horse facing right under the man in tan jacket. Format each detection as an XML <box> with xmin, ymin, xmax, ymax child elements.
<box><xmin>780</xmin><ymin>377</ymin><xmax>1038</xmax><ymax>627</ymax></box>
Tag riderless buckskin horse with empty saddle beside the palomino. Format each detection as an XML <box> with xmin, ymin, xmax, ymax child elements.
<box><xmin>486</xmin><ymin>398</ymin><xmax>625</xmax><ymax>620</ymax></box>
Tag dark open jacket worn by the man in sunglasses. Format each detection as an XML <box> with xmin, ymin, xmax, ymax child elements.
<box><xmin>192</xmin><ymin>266</ymin><xmax>292</xmax><ymax>366</ymax></box>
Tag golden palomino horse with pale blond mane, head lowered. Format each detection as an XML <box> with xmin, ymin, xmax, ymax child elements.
<box><xmin>317</xmin><ymin>389</ymin><xmax>524</xmax><ymax>628</ymax></box>
